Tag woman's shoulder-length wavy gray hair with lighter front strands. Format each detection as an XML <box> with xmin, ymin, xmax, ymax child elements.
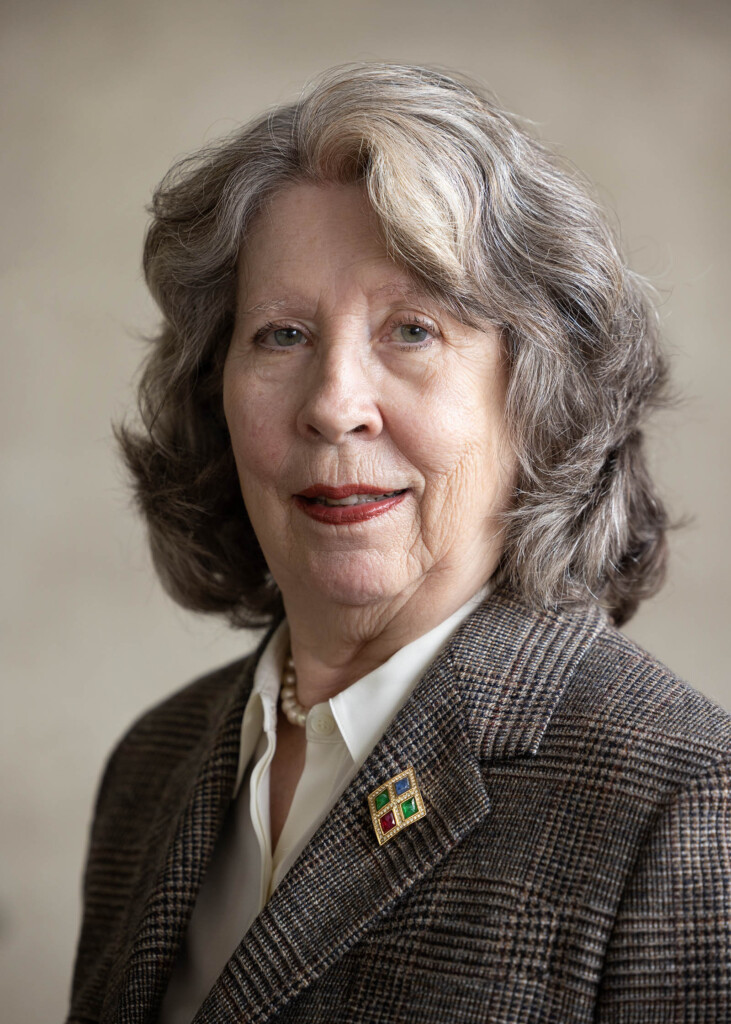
<box><xmin>118</xmin><ymin>63</ymin><xmax>667</xmax><ymax>626</ymax></box>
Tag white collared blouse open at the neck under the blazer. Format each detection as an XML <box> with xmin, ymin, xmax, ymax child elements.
<box><xmin>160</xmin><ymin>587</ymin><xmax>488</xmax><ymax>1024</ymax></box>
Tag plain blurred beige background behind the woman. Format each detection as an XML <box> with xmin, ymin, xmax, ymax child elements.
<box><xmin>0</xmin><ymin>0</ymin><xmax>731</xmax><ymax>1022</ymax></box>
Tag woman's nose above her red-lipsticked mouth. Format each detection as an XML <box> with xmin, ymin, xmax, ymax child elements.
<box><xmin>297</xmin><ymin>339</ymin><xmax>383</xmax><ymax>444</ymax></box>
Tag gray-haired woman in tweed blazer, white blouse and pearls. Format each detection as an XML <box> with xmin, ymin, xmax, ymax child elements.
<box><xmin>69</xmin><ymin>65</ymin><xmax>731</xmax><ymax>1024</ymax></box>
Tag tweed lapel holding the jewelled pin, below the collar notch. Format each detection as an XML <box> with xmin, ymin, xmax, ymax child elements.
<box><xmin>195</xmin><ymin>647</ymin><xmax>489</xmax><ymax>1024</ymax></box>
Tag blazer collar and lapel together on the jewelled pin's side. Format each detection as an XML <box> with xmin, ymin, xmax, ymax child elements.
<box><xmin>195</xmin><ymin>592</ymin><xmax>602</xmax><ymax>1024</ymax></box>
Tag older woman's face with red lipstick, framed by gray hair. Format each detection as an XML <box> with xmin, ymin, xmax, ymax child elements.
<box><xmin>223</xmin><ymin>184</ymin><xmax>514</xmax><ymax>605</ymax></box>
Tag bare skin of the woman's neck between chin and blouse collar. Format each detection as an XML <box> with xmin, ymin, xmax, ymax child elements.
<box><xmin>283</xmin><ymin>577</ymin><xmax>484</xmax><ymax>708</ymax></box>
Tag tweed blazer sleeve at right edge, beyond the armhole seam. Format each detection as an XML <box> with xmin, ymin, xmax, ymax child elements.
<box><xmin>596</xmin><ymin>763</ymin><xmax>731</xmax><ymax>1024</ymax></box>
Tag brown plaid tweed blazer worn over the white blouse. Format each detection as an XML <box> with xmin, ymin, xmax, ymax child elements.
<box><xmin>68</xmin><ymin>592</ymin><xmax>731</xmax><ymax>1024</ymax></box>
